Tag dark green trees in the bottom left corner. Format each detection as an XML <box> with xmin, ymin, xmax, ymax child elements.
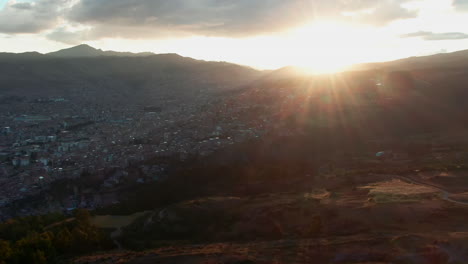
<box><xmin>0</xmin><ymin>209</ymin><xmax>113</xmax><ymax>264</ymax></box>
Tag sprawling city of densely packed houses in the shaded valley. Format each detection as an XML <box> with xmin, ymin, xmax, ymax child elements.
<box><xmin>0</xmin><ymin>86</ymin><xmax>278</xmax><ymax>217</ymax></box>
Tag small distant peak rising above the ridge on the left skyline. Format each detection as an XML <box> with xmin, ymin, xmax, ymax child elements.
<box><xmin>46</xmin><ymin>44</ymin><xmax>154</xmax><ymax>58</ymax></box>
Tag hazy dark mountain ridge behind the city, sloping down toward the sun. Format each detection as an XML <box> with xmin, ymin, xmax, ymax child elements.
<box><xmin>0</xmin><ymin>45</ymin><xmax>263</xmax><ymax>103</ymax></box>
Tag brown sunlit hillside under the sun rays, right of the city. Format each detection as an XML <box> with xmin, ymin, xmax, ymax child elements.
<box><xmin>71</xmin><ymin>51</ymin><xmax>468</xmax><ymax>264</ymax></box>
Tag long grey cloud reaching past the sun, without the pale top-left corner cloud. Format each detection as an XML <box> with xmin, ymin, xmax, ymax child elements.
<box><xmin>50</xmin><ymin>0</ymin><xmax>417</xmax><ymax>41</ymax></box>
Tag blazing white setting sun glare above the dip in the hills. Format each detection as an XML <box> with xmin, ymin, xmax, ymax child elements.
<box><xmin>288</xmin><ymin>21</ymin><xmax>369</xmax><ymax>73</ymax></box>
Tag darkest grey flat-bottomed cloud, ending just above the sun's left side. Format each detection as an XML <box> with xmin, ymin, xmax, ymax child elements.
<box><xmin>66</xmin><ymin>0</ymin><xmax>314</xmax><ymax>37</ymax></box>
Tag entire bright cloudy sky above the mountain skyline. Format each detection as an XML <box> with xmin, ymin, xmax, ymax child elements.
<box><xmin>0</xmin><ymin>0</ymin><xmax>468</xmax><ymax>71</ymax></box>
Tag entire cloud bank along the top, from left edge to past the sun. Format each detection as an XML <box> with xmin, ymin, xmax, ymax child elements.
<box><xmin>0</xmin><ymin>0</ymin><xmax>417</xmax><ymax>41</ymax></box>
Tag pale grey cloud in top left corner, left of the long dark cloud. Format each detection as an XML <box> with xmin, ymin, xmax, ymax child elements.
<box><xmin>0</xmin><ymin>0</ymin><xmax>68</xmax><ymax>34</ymax></box>
